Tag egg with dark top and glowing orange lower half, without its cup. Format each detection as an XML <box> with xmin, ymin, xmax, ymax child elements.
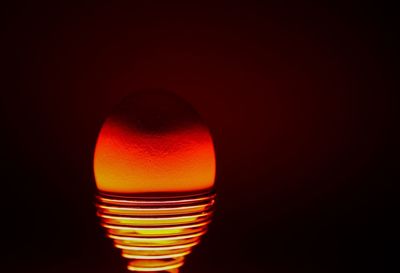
<box><xmin>94</xmin><ymin>91</ymin><xmax>215</xmax><ymax>194</ymax></box>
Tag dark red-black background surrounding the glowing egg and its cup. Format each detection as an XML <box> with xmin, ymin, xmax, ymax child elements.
<box><xmin>0</xmin><ymin>1</ymin><xmax>397</xmax><ymax>273</ymax></box>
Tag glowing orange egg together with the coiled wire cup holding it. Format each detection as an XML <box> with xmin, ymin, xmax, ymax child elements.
<box><xmin>94</xmin><ymin>91</ymin><xmax>215</xmax><ymax>272</ymax></box>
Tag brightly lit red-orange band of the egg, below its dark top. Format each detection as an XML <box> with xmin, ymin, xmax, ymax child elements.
<box><xmin>94</xmin><ymin>119</ymin><xmax>215</xmax><ymax>193</ymax></box>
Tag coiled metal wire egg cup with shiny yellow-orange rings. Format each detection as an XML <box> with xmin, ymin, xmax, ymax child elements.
<box><xmin>96</xmin><ymin>192</ymin><xmax>215</xmax><ymax>272</ymax></box>
